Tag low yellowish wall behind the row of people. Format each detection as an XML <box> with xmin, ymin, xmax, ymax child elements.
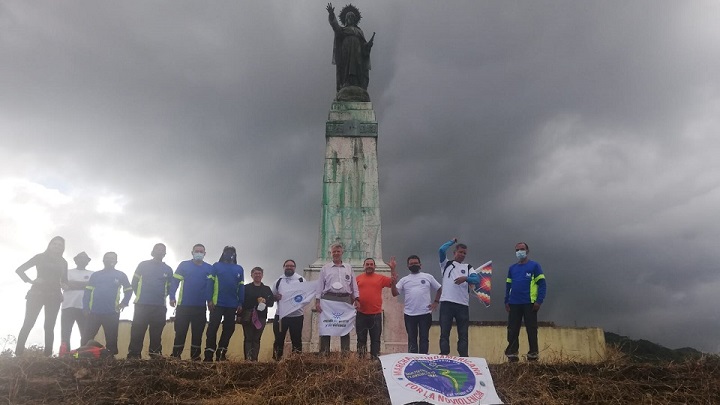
<box><xmin>104</xmin><ymin>320</ymin><xmax>605</xmax><ymax>363</ymax></box>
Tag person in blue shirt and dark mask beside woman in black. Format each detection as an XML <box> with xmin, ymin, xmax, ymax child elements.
<box><xmin>204</xmin><ymin>246</ymin><xmax>245</xmax><ymax>362</ymax></box>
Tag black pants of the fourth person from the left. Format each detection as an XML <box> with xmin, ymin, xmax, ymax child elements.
<box><xmin>128</xmin><ymin>304</ymin><xmax>167</xmax><ymax>359</ymax></box>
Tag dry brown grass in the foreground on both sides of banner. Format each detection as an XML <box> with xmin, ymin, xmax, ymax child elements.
<box><xmin>0</xmin><ymin>354</ymin><xmax>720</xmax><ymax>405</ymax></box>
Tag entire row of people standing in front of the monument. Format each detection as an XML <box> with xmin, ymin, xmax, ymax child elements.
<box><xmin>15</xmin><ymin>236</ymin><xmax>546</xmax><ymax>362</ymax></box>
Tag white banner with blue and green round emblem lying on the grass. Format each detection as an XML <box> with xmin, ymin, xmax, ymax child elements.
<box><xmin>380</xmin><ymin>353</ymin><xmax>502</xmax><ymax>405</ymax></box>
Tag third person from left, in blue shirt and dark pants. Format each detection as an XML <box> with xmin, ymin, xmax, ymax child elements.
<box><xmin>82</xmin><ymin>252</ymin><xmax>132</xmax><ymax>355</ymax></box>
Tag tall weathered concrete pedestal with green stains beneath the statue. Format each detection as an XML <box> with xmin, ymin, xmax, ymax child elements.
<box><xmin>303</xmin><ymin>101</ymin><xmax>407</xmax><ymax>353</ymax></box>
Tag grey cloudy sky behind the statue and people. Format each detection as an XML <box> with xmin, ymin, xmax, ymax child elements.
<box><xmin>0</xmin><ymin>0</ymin><xmax>720</xmax><ymax>352</ymax></box>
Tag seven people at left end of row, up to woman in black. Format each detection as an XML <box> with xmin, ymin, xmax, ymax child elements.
<box><xmin>15</xmin><ymin>240</ymin><xmax>275</xmax><ymax>362</ymax></box>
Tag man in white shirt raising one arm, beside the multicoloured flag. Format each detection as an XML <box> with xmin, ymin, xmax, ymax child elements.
<box><xmin>438</xmin><ymin>238</ymin><xmax>478</xmax><ymax>357</ymax></box>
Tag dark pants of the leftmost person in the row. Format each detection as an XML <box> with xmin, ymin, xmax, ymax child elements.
<box><xmin>15</xmin><ymin>293</ymin><xmax>62</xmax><ymax>357</ymax></box>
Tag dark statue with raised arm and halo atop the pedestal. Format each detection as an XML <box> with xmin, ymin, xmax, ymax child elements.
<box><xmin>327</xmin><ymin>3</ymin><xmax>375</xmax><ymax>101</ymax></box>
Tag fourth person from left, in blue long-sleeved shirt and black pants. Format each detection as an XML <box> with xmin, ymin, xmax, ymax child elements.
<box><xmin>127</xmin><ymin>243</ymin><xmax>172</xmax><ymax>359</ymax></box>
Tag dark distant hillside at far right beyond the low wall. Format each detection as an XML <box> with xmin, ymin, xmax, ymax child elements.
<box><xmin>605</xmin><ymin>332</ymin><xmax>703</xmax><ymax>362</ymax></box>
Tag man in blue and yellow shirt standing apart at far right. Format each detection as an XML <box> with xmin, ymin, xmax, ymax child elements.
<box><xmin>505</xmin><ymin>242</ymin><xmax>547</xmax><ymax>363</ymax></box>
